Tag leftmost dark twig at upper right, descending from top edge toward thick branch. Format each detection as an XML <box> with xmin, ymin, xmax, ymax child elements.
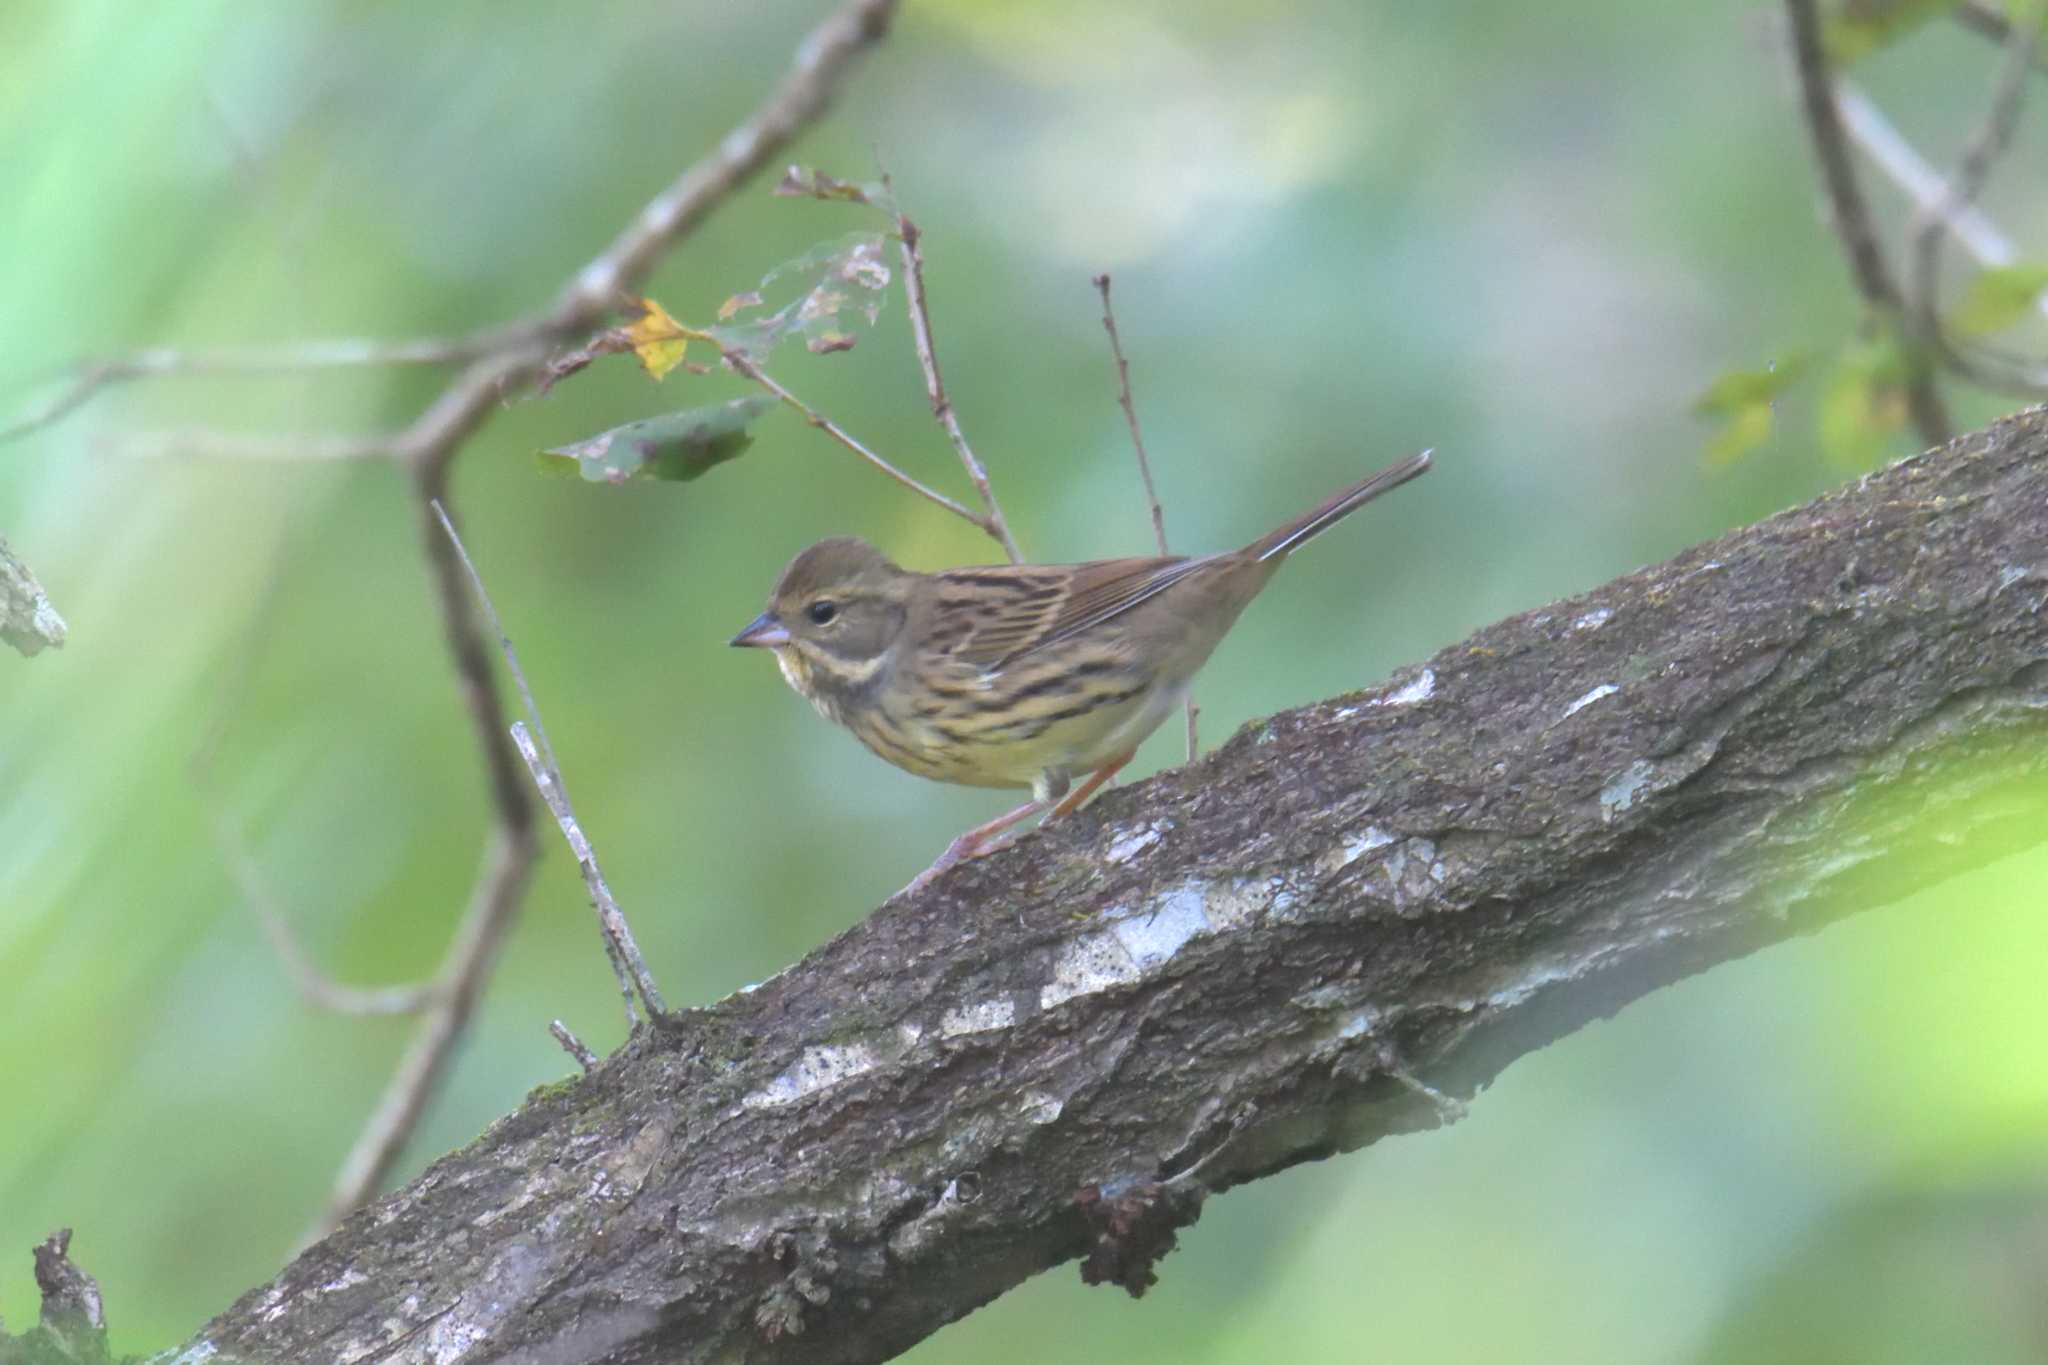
<box><xmin>1786</xmin><ymin>0</ymin><xmax>1950</xmax><ymax>446</ymax></box>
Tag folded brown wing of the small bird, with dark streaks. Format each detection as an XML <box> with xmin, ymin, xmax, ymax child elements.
<box><xmin>938</xmin><ymin>555</ymin><xmax>1217</xmax><ymax>671</ymax></box>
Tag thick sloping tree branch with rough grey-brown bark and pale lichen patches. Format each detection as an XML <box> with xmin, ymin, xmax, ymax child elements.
<box><xmin>167</xmin><ymin>411</ymin><xmax>2048</xmax><ymax>1365</ymax></box>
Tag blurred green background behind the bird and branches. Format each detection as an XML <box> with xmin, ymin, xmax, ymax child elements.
<box><xmin>0</xmin><ymin>0</ymin><xmax>2048</xmax><ymax>1363</ymax></box>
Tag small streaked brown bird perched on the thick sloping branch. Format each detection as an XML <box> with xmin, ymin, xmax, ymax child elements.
<box><xmin>733</xmin><ymin>450</ymin><xmax>1430</xmax><ymax>886</ymax></box>
